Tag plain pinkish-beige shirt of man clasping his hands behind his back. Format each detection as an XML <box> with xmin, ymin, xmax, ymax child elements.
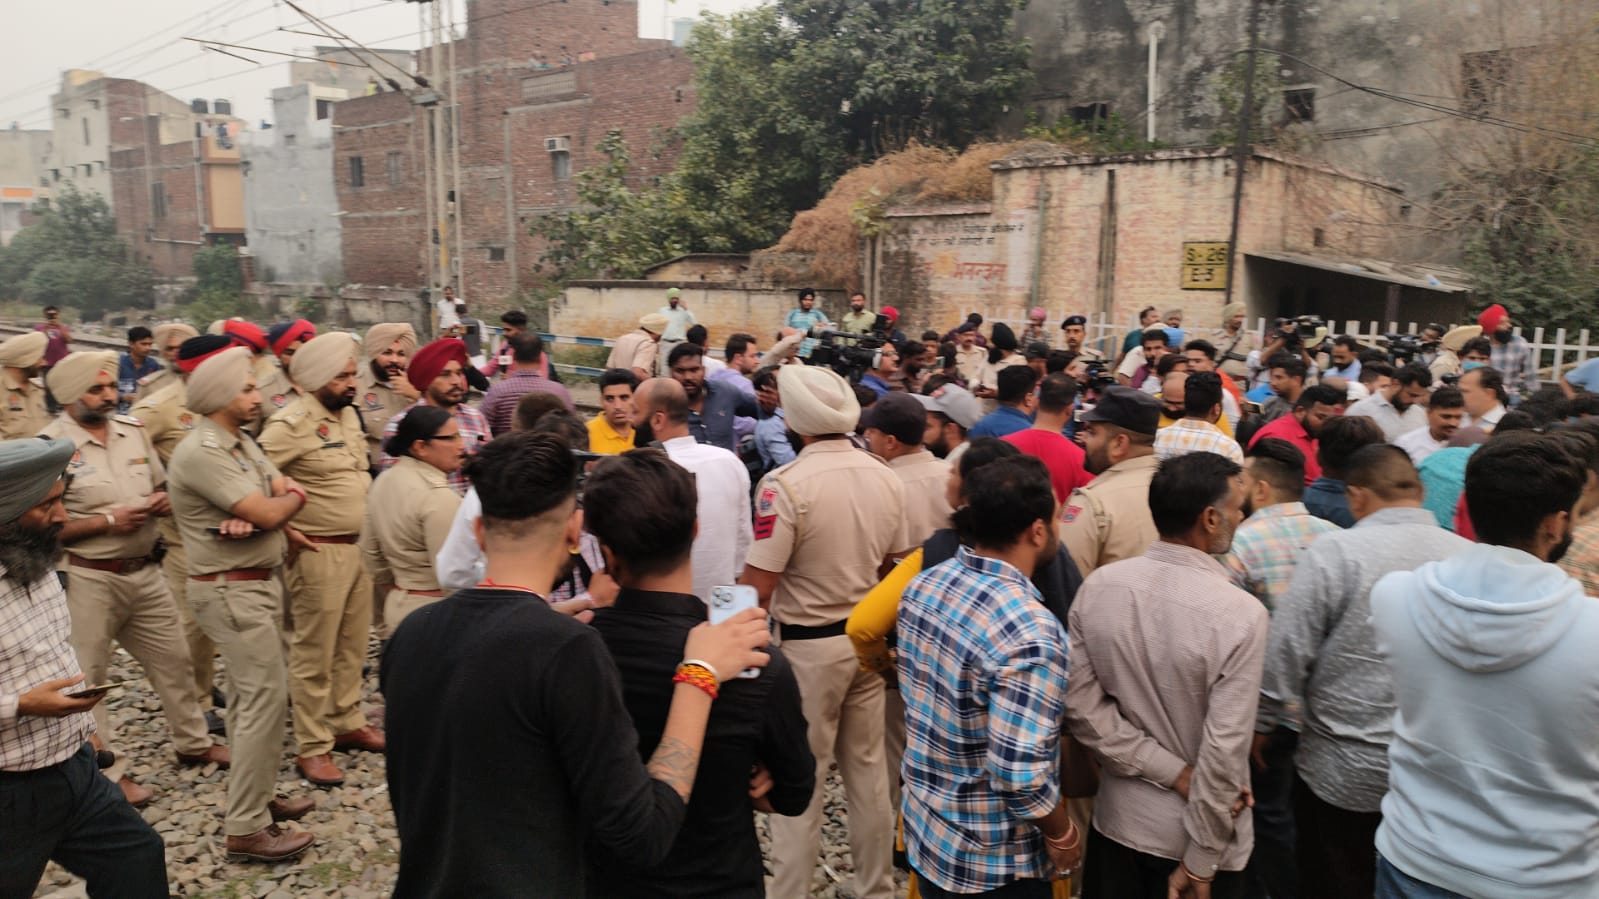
<box><xmin>1067</xmin><ymin>541</ymin><xmax>1266</xmax><ymax>877</ymax></box>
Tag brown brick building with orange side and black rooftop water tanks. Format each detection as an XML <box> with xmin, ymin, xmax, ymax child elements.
<box><xmin>110</xmin><ymin>122</ymin><xmax>245</xmax><ymax>278</ymax></box>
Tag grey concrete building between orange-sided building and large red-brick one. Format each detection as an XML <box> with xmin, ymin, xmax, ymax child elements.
<box><xmin>240</xmin><ymin>84</ymin><xmax>346</xmax><ymax>285</ymax></box>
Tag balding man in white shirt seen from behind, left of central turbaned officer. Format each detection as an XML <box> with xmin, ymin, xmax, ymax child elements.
<box><xmin>632</xmin><ymin>378</ymin><xmax>755</xmax><ymax>600</ymax></box>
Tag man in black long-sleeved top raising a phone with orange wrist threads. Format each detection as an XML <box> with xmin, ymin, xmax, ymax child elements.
<box><xmin>382</xmin><ymin>432</ymin><xmax>769</xmax><ymax>899</ymax></box>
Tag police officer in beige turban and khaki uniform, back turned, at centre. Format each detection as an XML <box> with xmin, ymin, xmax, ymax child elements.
<box><xmin>738</xmin><ymin>365</ymin><xmax>911</xmax><ymax>899</ymax></box>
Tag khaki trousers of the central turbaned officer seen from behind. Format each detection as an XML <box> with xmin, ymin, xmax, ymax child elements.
<box><xmin>769</xmin><ymin>635</ymin><xmax>894</xmax><ymax>899</ymax></box>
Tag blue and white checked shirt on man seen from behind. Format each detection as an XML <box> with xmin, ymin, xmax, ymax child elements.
<box><xmin>899</xmin><ymin>547</ymin><xmax>1067</xmax><ymax>893</ymax></box>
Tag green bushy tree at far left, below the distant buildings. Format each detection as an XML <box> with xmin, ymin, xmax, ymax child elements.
<box><xmin>0</xmin><ymin>184</ymin><xmax>154</xmax><ymax>320</ymax></box>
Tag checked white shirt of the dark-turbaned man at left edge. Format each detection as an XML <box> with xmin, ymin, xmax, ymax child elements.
<box><xmin>0</xmin><ymin>568</ymin><xmax>94</xmax><ymax>761</ymax></box>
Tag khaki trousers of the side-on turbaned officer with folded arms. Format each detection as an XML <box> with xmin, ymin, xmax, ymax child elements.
<box><xmin>189</xmin><ymin>577</ymin><xmax>288</xmax><ymax>837</ymax></box>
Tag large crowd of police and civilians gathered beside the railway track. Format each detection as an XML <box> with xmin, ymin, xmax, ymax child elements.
<box><xmin>0</xmin><ymin>290</ymin><xmax>1599</xmax><ymax>899</ymax></box>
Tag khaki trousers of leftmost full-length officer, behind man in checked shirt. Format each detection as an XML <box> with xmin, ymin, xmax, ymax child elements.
<box><xmin>66</xmin><ymin>565</ymin><xmax>211</xmax><ymax>781</ymax></box>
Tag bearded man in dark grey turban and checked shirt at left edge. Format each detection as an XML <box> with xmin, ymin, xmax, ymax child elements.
<box><xmin>0</xmin><ymin>438</ymin><xmax>166</xmax><ymax>899</ymax></box>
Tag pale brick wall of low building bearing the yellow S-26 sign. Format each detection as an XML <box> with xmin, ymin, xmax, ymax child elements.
<box><xmin>873</xmin><ymin>149</ymin><xmax>1438</xmax><ymax>330</ymax></box>
